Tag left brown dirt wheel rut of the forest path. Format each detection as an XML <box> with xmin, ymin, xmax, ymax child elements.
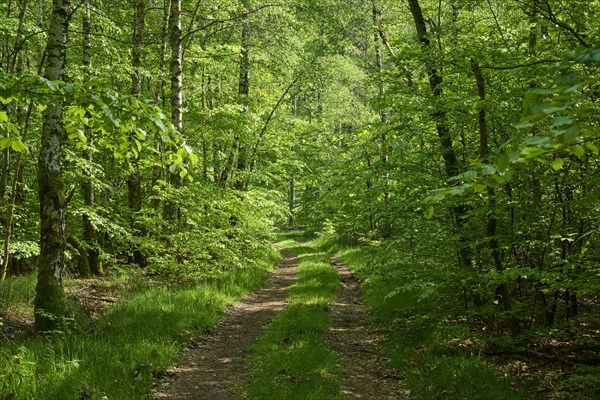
<box><xmin>154</xmin><ymin>253</ymin><xmax>298</xmax><ymax>400</ymax></box>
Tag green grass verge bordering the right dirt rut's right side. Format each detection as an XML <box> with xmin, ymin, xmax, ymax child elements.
<box><xmin>322</xmin><ymin>239</ymin><xmax>520</xmax><ymax>400</ymax></box>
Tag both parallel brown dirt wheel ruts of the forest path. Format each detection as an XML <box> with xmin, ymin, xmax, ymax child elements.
<box><xmin>154</xmin><ymin>254</ymin><xmax>406</xmax><ymax>400</ymax></box>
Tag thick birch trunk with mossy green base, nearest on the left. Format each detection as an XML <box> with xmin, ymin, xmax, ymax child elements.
<box><xmin>34</xmin><ymin>0</ymin><xmax>70</xmax><ymax>331</ymax></box>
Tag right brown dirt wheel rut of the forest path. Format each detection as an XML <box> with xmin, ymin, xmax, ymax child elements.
<box><xmin>328</xmin><ymin>257</ymin><xmax>408</xmax><ymax>400</ymax></box>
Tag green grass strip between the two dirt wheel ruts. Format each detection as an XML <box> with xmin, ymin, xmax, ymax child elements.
<box><xmin>246</xmin><ymin>239</ymin><xmax>341</xmax><ymax>400</ymax></box>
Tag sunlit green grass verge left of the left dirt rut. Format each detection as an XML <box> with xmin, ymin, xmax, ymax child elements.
<box><xmin>0</xmin><ymin>247</ymin><xmax>282</xmax><ymax>400</ymax></box>
